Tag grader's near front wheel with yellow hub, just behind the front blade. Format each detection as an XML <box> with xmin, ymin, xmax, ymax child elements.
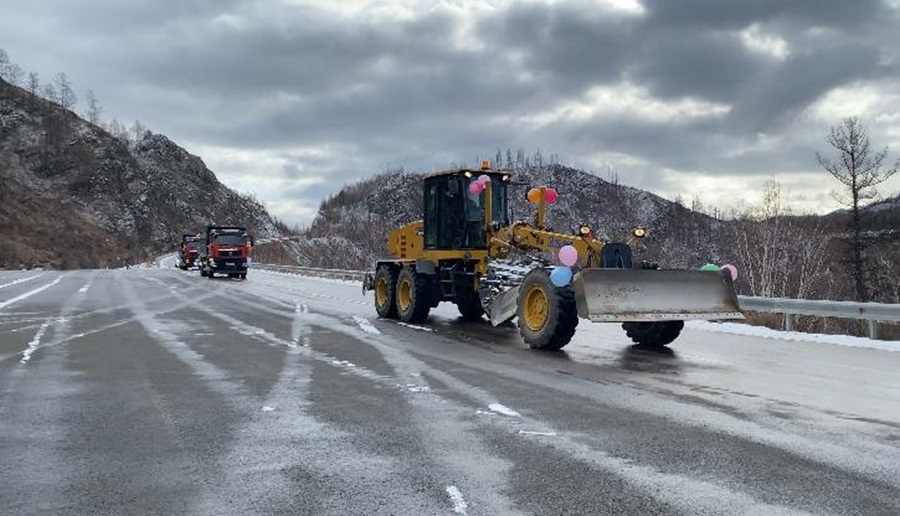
<box><xmin>516</xmin><ymin>269</ymin><xmax>578</xmax><ymax>351</ymax></box>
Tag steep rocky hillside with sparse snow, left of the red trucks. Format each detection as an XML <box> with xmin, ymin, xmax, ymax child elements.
<box><xmin>0</xmin><ymin>80</ymin><xmax>284</xmax><ymax>268</ymax></box>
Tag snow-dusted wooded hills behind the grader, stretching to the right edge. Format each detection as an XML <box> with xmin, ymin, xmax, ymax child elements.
<box><xmin>285</xmin><ymin>165</ymin><xmax>900</xmax><ymax>310</ymax></box>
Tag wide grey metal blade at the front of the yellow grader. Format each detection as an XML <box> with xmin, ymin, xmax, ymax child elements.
<box><xmin>572</xmin><ymin>269</ymin><xmax>744</xmax><ymax>322</ymax></box>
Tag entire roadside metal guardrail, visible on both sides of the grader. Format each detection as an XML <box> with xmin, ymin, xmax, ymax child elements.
<box><xmin>252</xmin><ymin>263</ymin><xmax>900</xmax><ymax>339</ymax></box>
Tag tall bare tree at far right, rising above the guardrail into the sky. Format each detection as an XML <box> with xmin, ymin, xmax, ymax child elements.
<box><xmin>816</xmin><ymin>117</ymin><xmax>900</xmax><ymax>301</ymax></box>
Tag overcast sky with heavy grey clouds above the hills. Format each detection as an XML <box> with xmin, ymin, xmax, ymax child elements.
<box><xmin>0</xmin><ymin>0</ymin><xmax>900</xmax><ymax>224</ymax></box>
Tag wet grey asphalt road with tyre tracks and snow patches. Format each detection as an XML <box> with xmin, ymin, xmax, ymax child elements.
<box><xmin>0</xmin><ymin>269</ymin><xmax>900</xmax><ymax>516</ymax></box>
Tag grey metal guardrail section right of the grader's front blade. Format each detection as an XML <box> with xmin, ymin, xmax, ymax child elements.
<box><xmin>738</xmin><ymin>296</ymin><xmax>900</xmax><ymax>339</ymax></box>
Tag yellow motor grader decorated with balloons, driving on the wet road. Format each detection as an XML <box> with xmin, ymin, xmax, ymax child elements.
<box><xmin>363</xmin><ymin>162</ymin><xmax>743</xmax><ymax>350</ymax></box>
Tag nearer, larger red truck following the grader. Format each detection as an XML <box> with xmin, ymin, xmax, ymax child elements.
<box><xmin>200</xmin><ymin>226</ymin><xmax>253</xmax><ymax>279</ymax></box>
